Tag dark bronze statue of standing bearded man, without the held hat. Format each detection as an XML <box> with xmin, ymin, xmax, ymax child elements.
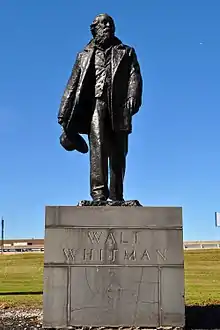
<box><xmin>58</xmin><ymin>14</ymin><xmax>142</xmax><ymax>202</ymax></box>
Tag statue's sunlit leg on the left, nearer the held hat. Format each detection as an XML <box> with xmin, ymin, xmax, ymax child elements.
<box><xmin>89</xmin><ymin>99</ymin><xmax>109</xmax><ymax>200</ymax></box>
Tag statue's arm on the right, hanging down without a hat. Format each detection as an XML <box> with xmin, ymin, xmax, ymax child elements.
<box><xmin>127</xmin><ymin>48</ymin><xmax>143</xmax><ymax>114</ymax></box>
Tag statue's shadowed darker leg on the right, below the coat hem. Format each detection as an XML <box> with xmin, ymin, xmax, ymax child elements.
<box><xmin>109</xmin><ymin>132</ymin><xmax>128</xmax><ymax>201</ymax></box>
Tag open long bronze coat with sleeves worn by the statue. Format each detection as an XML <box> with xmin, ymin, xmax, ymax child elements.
<box><xmin>58</xmin><ymin>37</ymin><xmax>142</xmax><ymax>134</ymax></box>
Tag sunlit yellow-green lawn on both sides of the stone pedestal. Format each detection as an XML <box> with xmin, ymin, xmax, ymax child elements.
<box><xmin>0</xmin><ymin>249</ymin><xmax>220</xmax><ymax>308</ymax></box>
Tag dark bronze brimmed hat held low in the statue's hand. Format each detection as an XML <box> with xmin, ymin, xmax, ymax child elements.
<box><xmin>60</xmin><ymin>132</ymin><xmax>89</xmax><ymax>154</ymax></box>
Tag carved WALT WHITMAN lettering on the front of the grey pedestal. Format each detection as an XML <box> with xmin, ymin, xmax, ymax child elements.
<box><xmin>63</xmin><ymin>229</ymin><xmax>168</xmax><ymax>265</ymax></box>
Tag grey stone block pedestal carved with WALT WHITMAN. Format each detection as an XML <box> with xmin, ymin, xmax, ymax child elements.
<box><xmin>43</xmin><ymin>206</ymin><xmax>185</xmax><ymax>328</ymax></box>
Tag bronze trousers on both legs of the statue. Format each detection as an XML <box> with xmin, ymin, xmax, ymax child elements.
<box><xmin>89</xmin><ymin>98</ymin><xmax>128</xmax><ymax>201</ymax></box>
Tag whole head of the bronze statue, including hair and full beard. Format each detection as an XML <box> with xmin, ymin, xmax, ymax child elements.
<box><xmin>90</xmin><ymin>14</ymin><xmax>115</xmax><ymax>45</ymax></box>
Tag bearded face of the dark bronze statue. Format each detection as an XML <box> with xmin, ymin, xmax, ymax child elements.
<box><xmin>95</xmin><ymin>14</ymin><xmax>114</xmax><ymax>41</ymax></box>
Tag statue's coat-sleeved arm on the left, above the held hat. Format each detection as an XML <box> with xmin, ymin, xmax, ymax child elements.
<box><xmin>58</xmin><ymin>54</ymin><xmax>81</xmax><ymax>125</ymax></box>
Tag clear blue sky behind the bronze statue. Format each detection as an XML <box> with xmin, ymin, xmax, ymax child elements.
<box><xmin>0</xmin><ymin>0</ymin><xmax>220</xmax><ymax>240</ymax></box>
